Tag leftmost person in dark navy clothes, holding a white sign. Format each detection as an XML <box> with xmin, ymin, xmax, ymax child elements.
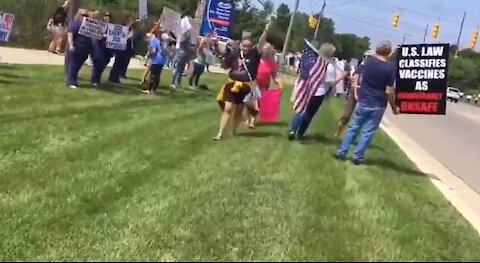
<box><xmin>67</xmin><ymin>9</ymin><xmax>93</xmax><ymax>89</ymax></box>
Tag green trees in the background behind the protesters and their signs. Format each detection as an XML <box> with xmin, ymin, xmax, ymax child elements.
<box><xmin>0</xmin><ymin>0</ymin><xmax>370</xmax><ymax>59</ymax></box>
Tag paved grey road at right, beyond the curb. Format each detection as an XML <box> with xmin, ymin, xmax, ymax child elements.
<box><xmin>388</xmin><ymin>103</ymin><xmax>480</xmax><ymax>193</ymax></box>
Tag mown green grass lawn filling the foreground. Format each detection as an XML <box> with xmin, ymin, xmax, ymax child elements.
<box><xmin>0</xmin><ymin>65</ymin><xmax>480</xmax><ymax>261</ymax></box>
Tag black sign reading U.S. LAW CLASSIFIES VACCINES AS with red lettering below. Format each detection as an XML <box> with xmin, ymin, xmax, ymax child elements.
<box><xmin>396</xmin><ymin>44</ymin><xmax>450</xmax><ymax>115</ymax></box>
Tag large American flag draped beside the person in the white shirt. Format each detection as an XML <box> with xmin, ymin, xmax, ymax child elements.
<box><xmin>293</xmin><ymin>40</ymin><xmax>328</xmax><ymax>113</ymax></box>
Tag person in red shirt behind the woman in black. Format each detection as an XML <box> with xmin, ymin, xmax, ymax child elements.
<box><xmin>244</xmin><ymin>43</ymin><xmax>283</xmax><ymax>129</ymax></box>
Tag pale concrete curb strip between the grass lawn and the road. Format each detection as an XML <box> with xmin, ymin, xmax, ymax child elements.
<box><xmin>380</xmin><ymin>117</ymin><xmax>480</xmax><ymax>234</ymax></box>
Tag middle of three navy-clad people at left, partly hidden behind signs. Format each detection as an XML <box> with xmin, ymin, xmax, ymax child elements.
<box><xmin>91</xmin><ymin>12</ymin><xmax>113</xmax><ymax>86</ymax></box>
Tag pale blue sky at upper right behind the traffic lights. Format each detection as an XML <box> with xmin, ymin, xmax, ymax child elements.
<box><xmin>266</xmin><ymin>0</ymin><xmax>480</xmax><ymax>50</ymax></box>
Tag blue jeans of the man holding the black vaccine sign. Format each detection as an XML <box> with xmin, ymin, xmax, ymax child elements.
<box><xmin>337</xmin><ymin>103</ymin><xmax>385</xmax><ymax>162</ymax></box>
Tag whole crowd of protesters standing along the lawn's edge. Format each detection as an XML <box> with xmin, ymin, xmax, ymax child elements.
<box><xmin>47</xmin><ymin>1</ymin><xmax>398</xmax><ymax>164</ymax></box>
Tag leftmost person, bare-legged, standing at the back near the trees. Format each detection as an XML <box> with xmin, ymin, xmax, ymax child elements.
<box><xmin>47</xmin><ymin>0</ymin><xmax>70</xmax><ymax>54</ymax></box>
